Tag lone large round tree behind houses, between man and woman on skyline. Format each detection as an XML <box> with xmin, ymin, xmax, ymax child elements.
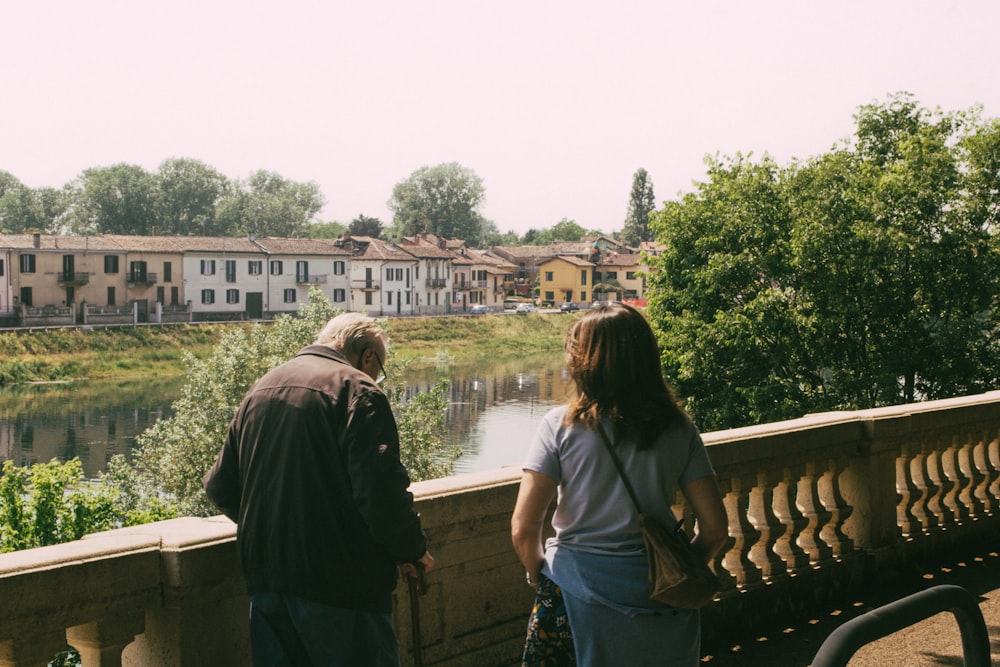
<box><xmin>388</xmin><ymin>162</ymin><xmax>486</xmax><ymax>244</ymax></box>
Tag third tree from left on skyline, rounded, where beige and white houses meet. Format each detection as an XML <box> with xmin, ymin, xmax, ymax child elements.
<box><xmin>156</xmin><ymin>158</ymin><xmax>230</xmax><ymax>236</ymax></box>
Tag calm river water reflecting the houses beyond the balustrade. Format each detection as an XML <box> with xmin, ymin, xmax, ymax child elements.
<box><xmin>0</xmin><ymin>352</ymin><xmax>568</xmax><ymax>477</ymax></box>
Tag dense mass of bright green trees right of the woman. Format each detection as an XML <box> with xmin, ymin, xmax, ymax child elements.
<box><xmin>649</xmin><ymin>94</ymin><xmax>1000</xmax><ymax>429</ymax></box>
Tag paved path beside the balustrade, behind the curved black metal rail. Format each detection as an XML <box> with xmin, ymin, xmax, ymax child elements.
<box><xmin>702</xmin><ymin>545</ymin><xmax>1000</xmax><ymax>667</ymax></box>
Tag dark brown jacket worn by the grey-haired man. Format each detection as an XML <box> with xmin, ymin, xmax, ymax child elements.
<box><xmin>203</xmin><ymin>345</ymin><xmax>427</xmax><ymax>612</ymax></box>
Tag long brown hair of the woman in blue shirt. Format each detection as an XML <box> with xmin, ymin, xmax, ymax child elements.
<box><xmin>564</xmin><ymin>302</ymin><xmax>687</xmax><ymax>447</ymax></box>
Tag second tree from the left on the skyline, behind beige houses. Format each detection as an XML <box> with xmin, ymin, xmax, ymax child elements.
<box><xmin>72</xmin><ymin>164</ymin><xmax>159</xmax><ymax>235</ymax></box>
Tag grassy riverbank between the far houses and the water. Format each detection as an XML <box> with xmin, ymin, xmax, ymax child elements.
<box><xmin>0</xmin><ymin>314</ymin><xmax>575</xmax><ymax>387</ymax></box>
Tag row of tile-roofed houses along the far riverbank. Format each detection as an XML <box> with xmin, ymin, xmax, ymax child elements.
<box><xmin>0</xmin><ymin>234</ymin><xmax>660</xmax><ymax>326</ymax></box>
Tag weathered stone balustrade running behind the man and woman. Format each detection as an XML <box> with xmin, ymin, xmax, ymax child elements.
<box><xmin>0</xmin><ymin>392</ymin><xmax>1000</xmax><ymax>667</ymax></box>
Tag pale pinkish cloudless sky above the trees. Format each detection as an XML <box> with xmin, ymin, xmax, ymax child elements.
<box><xmin>0</xmin><ymin>0</ymin><xmax>1000</xmax><ymax>234</ymax></box>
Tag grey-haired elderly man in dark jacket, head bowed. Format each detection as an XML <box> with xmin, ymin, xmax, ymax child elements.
<box><xmin>203</xmin><ymin>313</ymin><xmax>434</xmax><ymax>666</ymax></box>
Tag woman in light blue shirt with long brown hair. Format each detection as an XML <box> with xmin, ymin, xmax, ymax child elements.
<box><xmin>511</xmin><ymin>303</ymin><xmax>728</xmax><ymax>667</ymax></box>
